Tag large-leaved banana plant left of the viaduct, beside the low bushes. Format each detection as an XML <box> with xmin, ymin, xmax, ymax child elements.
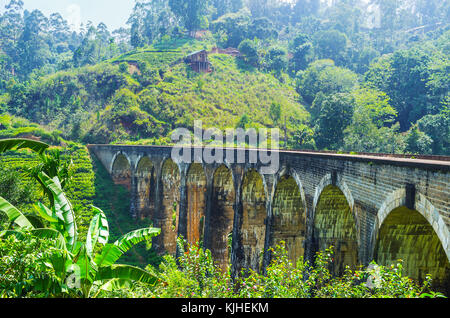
<box><xmin>0</xmin><ymin>166</ymin><xmax>160</xmax><ymax>297</ymax></box>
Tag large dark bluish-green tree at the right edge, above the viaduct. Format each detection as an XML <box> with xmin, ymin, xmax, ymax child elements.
<box><xmin>365</xmin><ymin>42</ymin><xmax>449</xmax><ymax>131</ymax></box>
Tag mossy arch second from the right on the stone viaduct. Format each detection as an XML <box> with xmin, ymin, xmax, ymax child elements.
<box><xmin>312</xmin><ymin>178</ymin><xmax>360</xmax><ymax>275</ymax></box>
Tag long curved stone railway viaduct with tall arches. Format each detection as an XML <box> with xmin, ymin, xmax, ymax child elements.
<box><xmin>88</xmin><ymin>145</ymin><xmax>450</xmax><ymax>292</ymax></box>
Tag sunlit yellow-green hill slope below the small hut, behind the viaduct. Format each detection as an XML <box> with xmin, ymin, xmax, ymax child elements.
<box><xmin>2</xmin><ymin>40</ymin><xmax>309</xmax><ymax>143</ymax></box>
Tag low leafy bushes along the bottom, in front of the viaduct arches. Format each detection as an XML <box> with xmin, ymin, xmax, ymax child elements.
<box><xmin>99</xmin><ymin>242</ymin><xmax>443</xmax><ymax>298</ymax></box>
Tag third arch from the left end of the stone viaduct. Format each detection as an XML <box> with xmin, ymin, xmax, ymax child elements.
<box><xmin>155</xmin><ymin>158</ymin><xmax>181</xmax><ymax>255</ymax></box>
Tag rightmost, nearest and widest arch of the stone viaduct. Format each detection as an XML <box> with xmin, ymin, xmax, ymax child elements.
<box><xmin>374</xmin><ymin>189</ymin><xmax>450</xmax><ymax>294</ymax></box>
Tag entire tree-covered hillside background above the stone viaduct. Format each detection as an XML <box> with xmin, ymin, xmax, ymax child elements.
<box><xmin>0</xmin><ymin>0</ymin><xmax>450</xmax><ymax>155</ymax></box>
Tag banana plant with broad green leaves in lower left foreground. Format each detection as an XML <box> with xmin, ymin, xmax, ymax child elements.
<box><xmin>0</xmin><ymin>141</ymin><xmax>160</xmax><ymax>297</ymax></box>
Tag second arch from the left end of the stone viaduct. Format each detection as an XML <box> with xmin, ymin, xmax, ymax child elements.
<box><xmin>136</xmin><ymin>156</ymin><xmax>156</xmax><ymax>219</ymax></box>
